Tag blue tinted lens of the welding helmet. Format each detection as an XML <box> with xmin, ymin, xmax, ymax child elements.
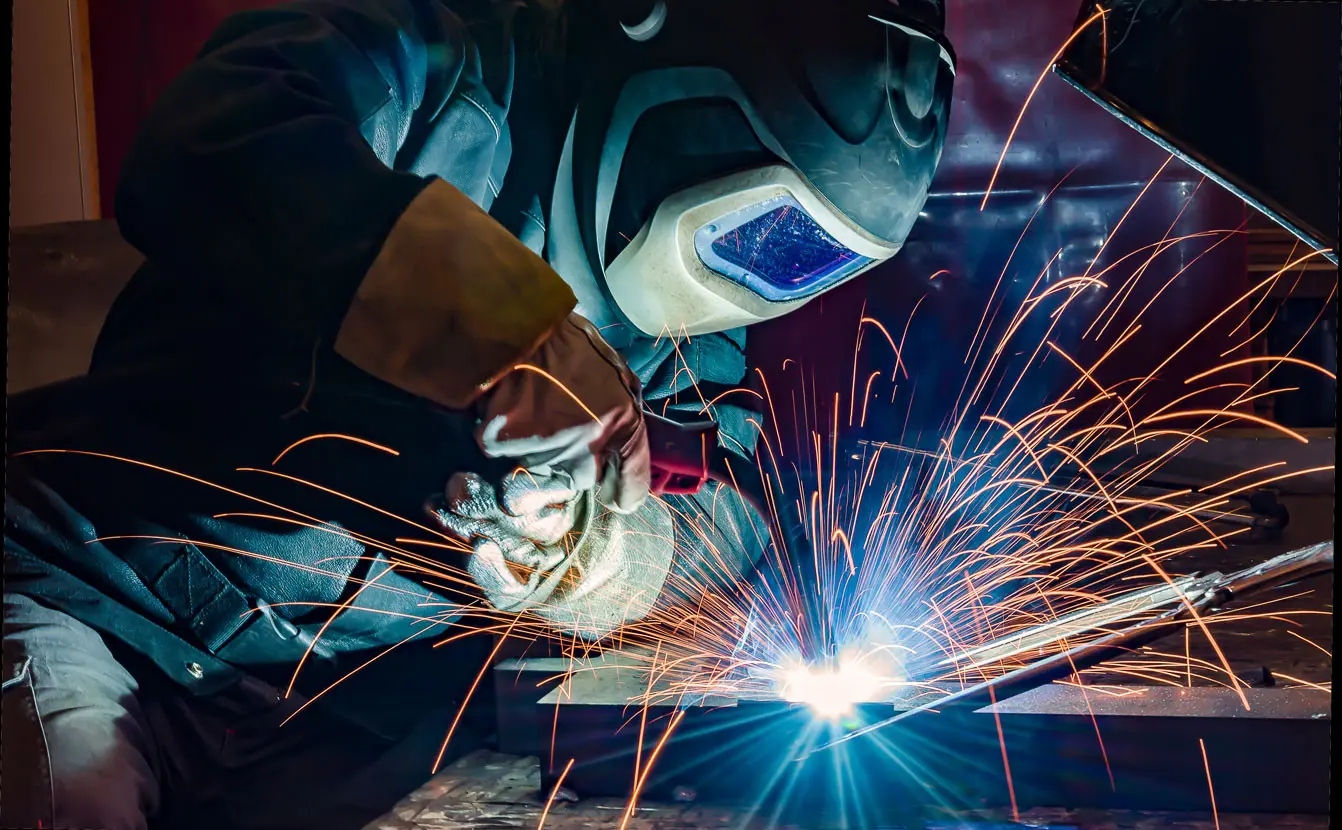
<box><xmin>694</xmin><ymin>196</ymin><xmax>872</xmax><ymax>301</ymax></box>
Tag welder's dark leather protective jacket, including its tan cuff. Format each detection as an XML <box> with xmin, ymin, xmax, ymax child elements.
<box><xmin>5</xmin><ymin>0</ymin><xmax>756</xmax><ymax>729</ymax></box>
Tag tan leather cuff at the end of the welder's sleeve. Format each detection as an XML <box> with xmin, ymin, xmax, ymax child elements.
<box><xmin>336</xmin><ymin>180</ymin><xmax>577</xmax><ymax>410</ymax></box>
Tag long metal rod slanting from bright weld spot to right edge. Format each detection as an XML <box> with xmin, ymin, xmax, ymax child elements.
<box><xmin>797</xmin><ymin>540</ymin><xmax>1333</xmax><ymax>762</ymax></box>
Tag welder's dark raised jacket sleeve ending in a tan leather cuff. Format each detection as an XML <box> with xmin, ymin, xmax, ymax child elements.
<box><xmin>117</xmin><ymin>0</ymin><xmax>574</xmax><ymax>408</ymax></box>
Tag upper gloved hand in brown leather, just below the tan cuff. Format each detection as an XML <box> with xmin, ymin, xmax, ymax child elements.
<box><xmin>476</xmin><ymin>314</ymin><xmax>650</xmax><ymax>513</ymax></box>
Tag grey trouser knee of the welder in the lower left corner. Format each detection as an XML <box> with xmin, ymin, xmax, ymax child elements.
<box><xmin>0</xmin><ymin>594</ymin><xmax>160</xmax><ymax>830</ymax></box>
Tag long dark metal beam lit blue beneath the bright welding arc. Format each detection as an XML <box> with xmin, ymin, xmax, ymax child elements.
<box><xmin>541</xmin><ymin>674</ymin><xmax>1331</xmax><ymax>827</ymax></box>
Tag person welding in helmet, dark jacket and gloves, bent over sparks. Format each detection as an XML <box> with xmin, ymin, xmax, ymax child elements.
<box><xmin>0</xmin><ymin>0</ymin><xmax>954</xmax><ymax>830</ymax></box>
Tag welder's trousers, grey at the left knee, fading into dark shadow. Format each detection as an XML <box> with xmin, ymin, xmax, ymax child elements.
<box><xmin>0</xmin><ymin>594</ymin><xmax>483</xmax><ymax>830</ymax></box>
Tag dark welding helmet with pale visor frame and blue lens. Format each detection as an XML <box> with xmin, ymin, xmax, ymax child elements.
<box><xmin>557</xmin><ymin>0</ymin><xmax>956</xmax><ymax>336</ymax></box>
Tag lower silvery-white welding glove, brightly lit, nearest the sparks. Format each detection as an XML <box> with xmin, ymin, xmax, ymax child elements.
<box><xmin>429</xmin><ymin>470</ymin><xmax>674</xmax><ymax>639</ymax></box>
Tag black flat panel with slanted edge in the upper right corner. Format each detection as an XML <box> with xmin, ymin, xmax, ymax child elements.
<box><xmin>1059</xmin><ymin>0</ymin><xmax>1342</xmax><ymax>263</ymax></box>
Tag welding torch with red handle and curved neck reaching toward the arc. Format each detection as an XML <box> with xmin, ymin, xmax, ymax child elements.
<box><xmin>643</xmin><ymin>410</ymin><xmax>835</xmax><ymax>665</ymax></box>
